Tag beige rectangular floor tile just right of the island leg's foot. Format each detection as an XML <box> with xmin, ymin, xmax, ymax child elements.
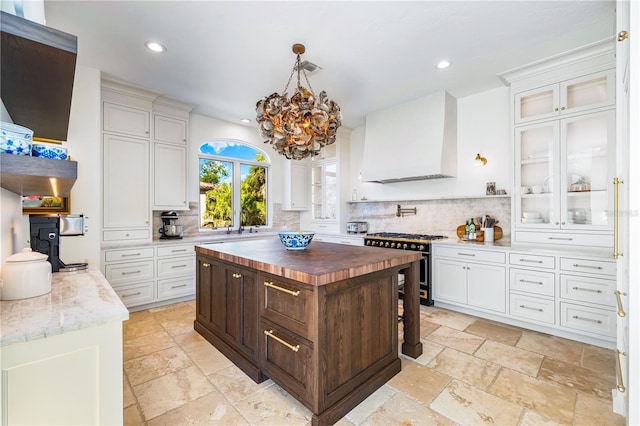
<box><xmin>428</xmin><ymin>348</ymin><xmax>501</xmax><ymax>389</ymax></box>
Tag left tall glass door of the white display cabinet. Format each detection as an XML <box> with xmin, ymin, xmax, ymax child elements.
<box><xmin>516</xmin><ymin>121</ymin><xmax>560</xmax><ymax>228</ymax></box>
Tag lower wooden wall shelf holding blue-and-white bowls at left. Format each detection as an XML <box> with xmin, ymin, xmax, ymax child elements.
<box><xmin>0</xmin><ymin>154</ymin><xmax>78</xmax><ymax>197</ymax></box>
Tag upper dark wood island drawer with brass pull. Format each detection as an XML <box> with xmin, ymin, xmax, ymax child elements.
<box><xmin>258</xmin><ymin>274</ymin><xmax>313</xmax><ymax>336</ymax></box>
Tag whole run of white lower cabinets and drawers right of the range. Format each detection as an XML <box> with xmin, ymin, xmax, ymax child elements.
<box><xmin>432</xmin><ymin>243</ymin><xmax>617</xmax><ymax>347</ymax></box>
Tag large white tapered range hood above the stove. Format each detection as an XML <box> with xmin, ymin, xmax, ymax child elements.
<box><xmin>361</xmin><ymin>91</ymin><xmax>457</xmax><ymax>183</ymax></box>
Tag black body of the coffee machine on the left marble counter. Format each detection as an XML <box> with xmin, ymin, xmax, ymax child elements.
<box><xmin>29</xmin><ymin>215</ymin><xmax>88</xmax><ymax>272</ymax></box>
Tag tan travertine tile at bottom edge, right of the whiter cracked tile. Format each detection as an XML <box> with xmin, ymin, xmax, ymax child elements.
<box><xmin>489</xmin><ymin>368</ymin><xmax>576</xmax><ymax>424</ymax></box>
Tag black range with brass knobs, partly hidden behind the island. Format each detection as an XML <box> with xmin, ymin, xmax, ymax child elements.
<box><xmin>364</xmin><ymin>232</ymin><xmax>447</xmax><ymax>306</ymax></box>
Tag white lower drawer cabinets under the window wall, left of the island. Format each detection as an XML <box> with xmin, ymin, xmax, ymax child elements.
<box><xmin>103</xmin><ymin>243</ymin><xmax>196</xmax><ymax>308</ymax></box>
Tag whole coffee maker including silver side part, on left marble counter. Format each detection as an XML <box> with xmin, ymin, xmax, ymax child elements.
<box><xmin>29</xmin><ymin>214</ymin><xmax>88</xmax><ymax>272</ymax></box>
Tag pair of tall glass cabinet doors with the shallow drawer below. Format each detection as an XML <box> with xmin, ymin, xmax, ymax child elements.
<box><xmin>514</xmin><ymin>109</ymin><xmax>615</xmax><ymax>247</ymax></box>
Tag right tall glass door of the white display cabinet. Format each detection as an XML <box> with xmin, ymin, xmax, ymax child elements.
<box><xmin>560</xmin><ymin>111</ymin><xmax>615</xmax><ymax>230</ymax></box>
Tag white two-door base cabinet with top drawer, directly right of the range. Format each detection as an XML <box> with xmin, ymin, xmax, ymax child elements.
<box><xmin>433</xmin><ymin>247</ymin><xmax>507</xmax><ymax>314</ymax></box>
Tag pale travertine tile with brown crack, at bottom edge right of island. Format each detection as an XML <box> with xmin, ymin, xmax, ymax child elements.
<box><xmin>431</xmin><ymin>380</ymin><xmax>522</xmax><ymax>425</ymax></box>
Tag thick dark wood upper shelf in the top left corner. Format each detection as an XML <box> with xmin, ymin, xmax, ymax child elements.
<box><xmin>0</xmin><ymin>12</ymin><xmax>78</xmax><ymax>141</ymax></box>
